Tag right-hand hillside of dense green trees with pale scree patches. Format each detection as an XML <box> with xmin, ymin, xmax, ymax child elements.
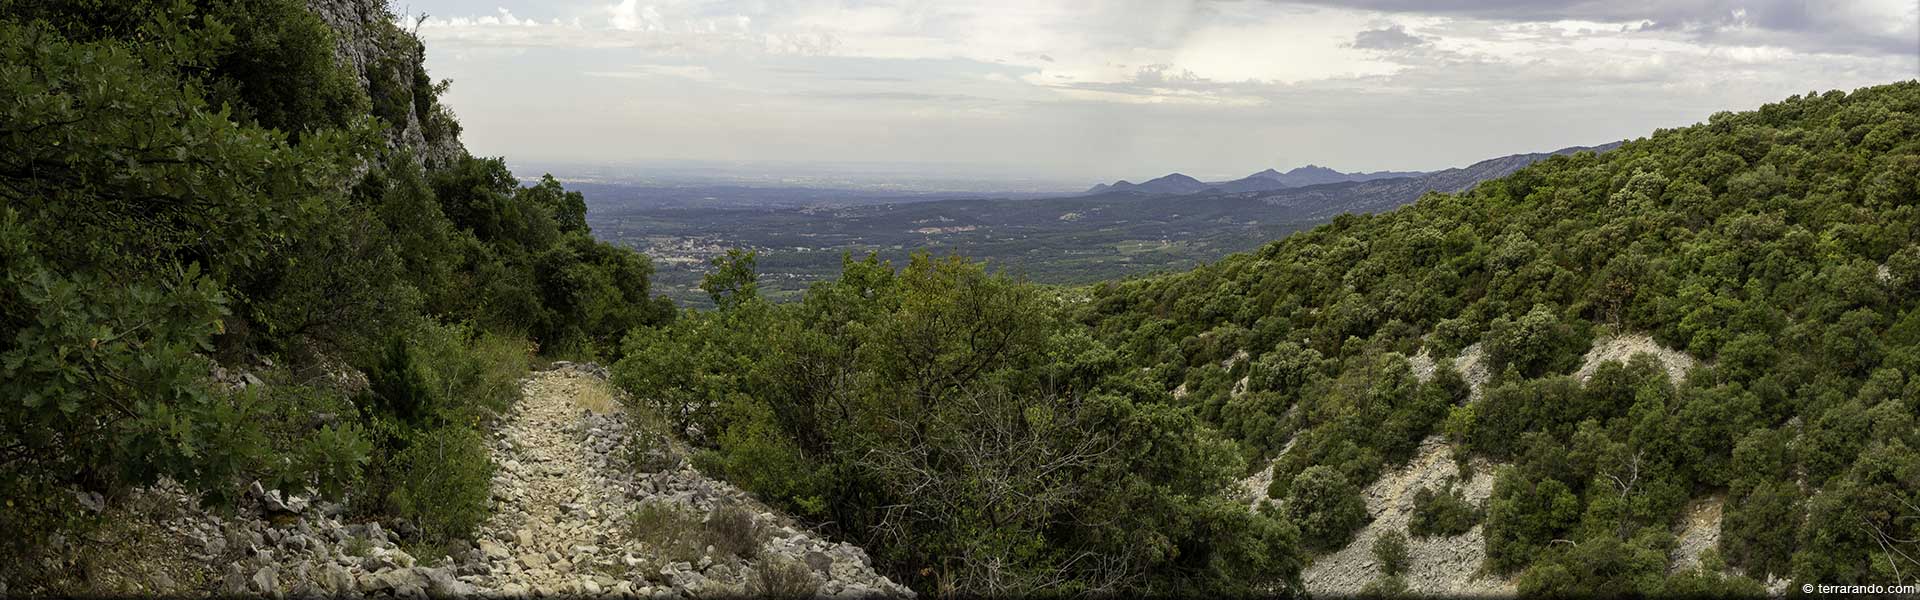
<box><xmin>1073</xmin><ymin>81</ymin><xmax>1920</xmax><ymax>594</ymax></box>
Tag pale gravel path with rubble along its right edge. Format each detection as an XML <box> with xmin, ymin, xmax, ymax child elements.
<box><xmin>467</xmin><ymin>363</ymin><xmax>912</xmax><ymax>598</ymax></box>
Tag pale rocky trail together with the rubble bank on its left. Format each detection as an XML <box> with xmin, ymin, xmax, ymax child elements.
<box><xmin>18</xmin><ymin>363</ymin><xmax>912</xmax><ymax>598</ymax></box>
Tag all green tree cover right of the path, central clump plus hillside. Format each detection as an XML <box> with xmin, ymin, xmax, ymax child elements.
<box><xmin>612</xmin><ymin>83</ymin><xmax>1920</xmax><ymax>596</ymax></box>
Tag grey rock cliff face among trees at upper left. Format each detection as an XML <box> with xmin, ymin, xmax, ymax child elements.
<box><xmin>307</xmin><ymin>0</ymin><xmax>467</xmax><ymax>169</ymax></box>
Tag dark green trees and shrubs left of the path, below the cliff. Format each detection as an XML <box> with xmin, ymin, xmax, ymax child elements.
<box><xmin>0</xmin><ymin>0</ymin><xmax>672</xmax><ymax>579</ymax></box>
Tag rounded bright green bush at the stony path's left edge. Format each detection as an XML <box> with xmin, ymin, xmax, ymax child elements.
<box><xmin>388</xmin><ymin>427</ymin><xmax>493</xmax><ymax>546</ymax></box>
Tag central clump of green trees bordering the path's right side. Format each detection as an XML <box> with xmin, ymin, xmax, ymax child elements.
<box><xmin>614</xmin><ymin>252</ymin><xmax>1300</xmax><ymax>592</ymax></box>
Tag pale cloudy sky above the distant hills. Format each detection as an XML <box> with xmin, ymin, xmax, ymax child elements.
<box><xmin>392</xmin><ymin>0</ymin><xmax>1920</xmax><ymax>183</ymax></box>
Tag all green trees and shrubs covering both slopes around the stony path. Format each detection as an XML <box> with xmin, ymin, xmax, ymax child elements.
<box><xmin>0</xmin><ymin>0</ymin><xmax>1920</xmax><ymax>596</ymax></box>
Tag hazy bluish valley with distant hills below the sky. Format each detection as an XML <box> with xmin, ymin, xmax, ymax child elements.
<box><xmin>587</xmin><ymin>144</ymin><xmax>1617</xmax><ymax>308</ymax></box>
